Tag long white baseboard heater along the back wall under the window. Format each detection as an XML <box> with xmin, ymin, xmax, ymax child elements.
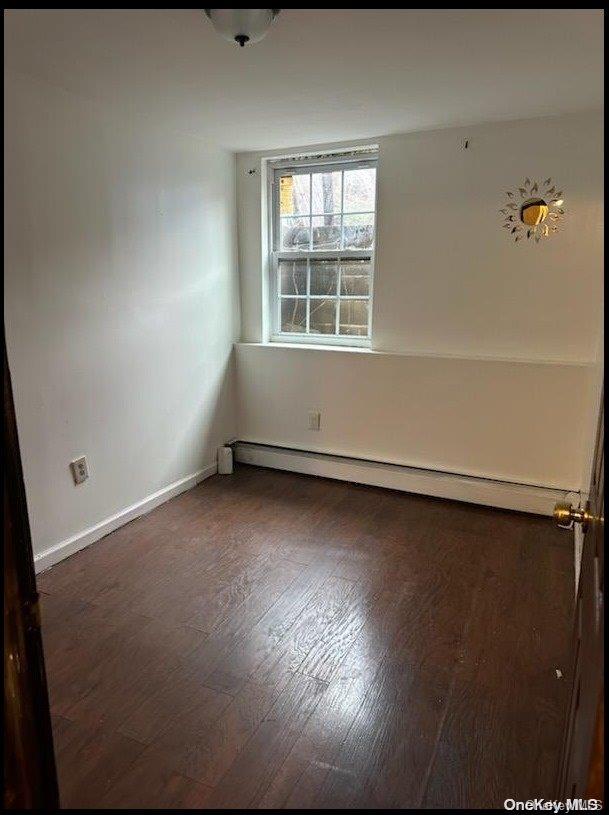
<box><xmin>234</xmin><ymin>441</ymin><xmax>570</xmax><ymax>515</ymax></box>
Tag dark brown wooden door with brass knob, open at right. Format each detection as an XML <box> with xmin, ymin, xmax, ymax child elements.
<box><xmin>558</xmin><ymin>390</ymin><xmax>605</xmax><ymax>800</ymax></box>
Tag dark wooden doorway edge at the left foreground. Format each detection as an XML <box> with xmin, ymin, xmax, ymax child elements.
<box><xmin>3</xmin><ymin>332</ymin><xmax>59</xmax><ymax>810</ymax></box>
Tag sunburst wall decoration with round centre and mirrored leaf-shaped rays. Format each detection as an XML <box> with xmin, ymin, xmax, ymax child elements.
<box><xmin>499</xmin><ymin>178</ymin><xmax>565</xmax><ymax>243</ymax></box>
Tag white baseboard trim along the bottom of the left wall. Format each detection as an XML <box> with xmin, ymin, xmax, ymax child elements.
<box><xmin>34</xmin><ymin>463</ymin><xmax>218</xmax><ymax>574</ymax></box>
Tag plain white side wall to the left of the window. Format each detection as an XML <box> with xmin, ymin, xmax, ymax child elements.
<box><xmin>5</xmin><ymin>75</ymin><xmax>239</xmax><ymax>554</ymax></box>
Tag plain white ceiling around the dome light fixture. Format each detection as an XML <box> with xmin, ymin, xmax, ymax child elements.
<box><xmin>5</xmin><ymin>9</ymin><xmax>603</xmax><ymax>150</ymax></box>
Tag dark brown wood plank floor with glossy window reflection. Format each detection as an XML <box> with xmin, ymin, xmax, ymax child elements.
<box><xmin>39</xmin><ymin>466</ymin><xmax>573</xmax><ymax>809</ymax></box>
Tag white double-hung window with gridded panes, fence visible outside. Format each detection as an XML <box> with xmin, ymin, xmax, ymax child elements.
<box><xmin>270</xmin><ymin>156</ymin><xmax>376</xmax><ymax>345</ymax></box>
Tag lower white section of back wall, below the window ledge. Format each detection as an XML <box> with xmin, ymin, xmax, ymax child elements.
<box><xmin>237</xmin><ymin>344</ymin><xmax>591</xmax><ymax>490</ymax></box>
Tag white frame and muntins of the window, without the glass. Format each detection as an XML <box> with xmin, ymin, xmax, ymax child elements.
<box><xmin>268</xmin><ymin>152</ymin><xmax>378</xmax><ymax>348</ymax></box>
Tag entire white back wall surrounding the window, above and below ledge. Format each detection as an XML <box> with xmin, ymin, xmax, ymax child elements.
<box><xmin>237</xmin><ymin>114</ymin><xmax>603</xmax><ymax>490</ymax></box>
